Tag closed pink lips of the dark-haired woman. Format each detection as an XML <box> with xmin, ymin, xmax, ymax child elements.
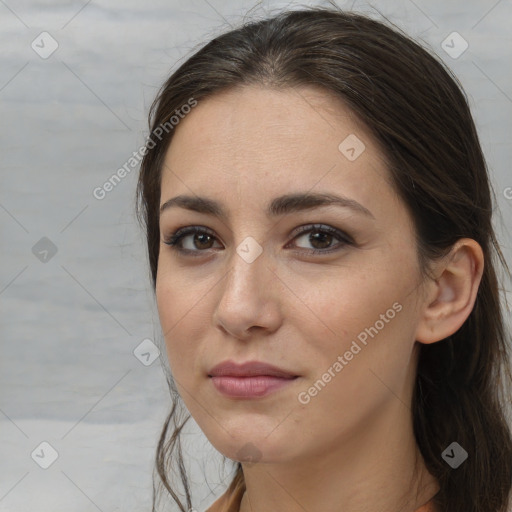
<box><xmin>208</xmin><ymin>361</ymin><xmax>298</xmax><ymax>398</ymax></box>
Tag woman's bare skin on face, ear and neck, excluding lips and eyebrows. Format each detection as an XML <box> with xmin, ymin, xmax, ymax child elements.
<box><xmin>156</xmin><ymin>86</ymin><xmax>483</xmax><ymax>512</ymax></box>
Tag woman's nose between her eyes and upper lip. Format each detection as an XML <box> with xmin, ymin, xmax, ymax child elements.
<box><xmin>213</xmin><ymin>246</ymin><xmax>282</xmax><ymax>340</ymax></box>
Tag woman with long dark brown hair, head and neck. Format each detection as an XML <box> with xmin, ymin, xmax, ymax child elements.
<box><xmin>138</xmin><ymin>8</ymin><xmax>512</xmax><ymax>512</ymax></box>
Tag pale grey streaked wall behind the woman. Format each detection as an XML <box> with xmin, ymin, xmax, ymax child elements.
<box><xmin>0</xmin><ymin>0</ymin><xmax>512</xmax><ymax>512</ymax></box>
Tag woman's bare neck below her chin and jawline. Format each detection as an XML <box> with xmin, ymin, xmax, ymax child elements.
<box><xmin>240</xmin><ymin>398</ymin><xmax>439</xmax><ymax>512</ymax></box>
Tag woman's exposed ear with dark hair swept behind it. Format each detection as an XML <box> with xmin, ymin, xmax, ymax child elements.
<box><xmin>415</xmin><ymin>238</ymin><xmax>484</xmax><ymax>344</ymax></box>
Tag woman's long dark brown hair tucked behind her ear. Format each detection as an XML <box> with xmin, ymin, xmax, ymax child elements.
<box><xmin>137</xmin><ymin>6</ymin><xmax>512</xmax><ymax>512</ymax></box>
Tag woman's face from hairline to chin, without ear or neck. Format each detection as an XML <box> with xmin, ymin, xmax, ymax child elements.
<box><xmin>156</xmin><ymin>87</ymin><xmax>428</xmax><ymax>462</ymax></box>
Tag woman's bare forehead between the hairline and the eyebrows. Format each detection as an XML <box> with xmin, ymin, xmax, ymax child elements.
<box><xmin>162</xmin><ymin>86</ymin><xmax>391</xmax><ymax>213</ymax></box>
